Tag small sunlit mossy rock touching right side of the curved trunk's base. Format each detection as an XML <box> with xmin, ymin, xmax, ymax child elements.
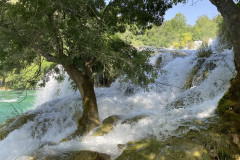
<box><xmin>93</xmin><ymin>115</ymin><xmax>121</xmax><ymax>136</ymax></box>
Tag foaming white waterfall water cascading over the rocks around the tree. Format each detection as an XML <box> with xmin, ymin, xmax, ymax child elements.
<box><xmin>0</xmin><ymin>39</ymin><xmax>234</xmax><ymax>160</ymax></box>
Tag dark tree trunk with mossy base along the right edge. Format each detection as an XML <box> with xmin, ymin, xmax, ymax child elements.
<box><xmin>210</xmin><ymin>0</ymin><xmax>240</xmax><ymax>132</ymax></box>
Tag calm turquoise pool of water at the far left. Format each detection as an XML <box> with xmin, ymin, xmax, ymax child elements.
<box><xmin>0</xmin><ymin>90</ymin><xmax>36</xmax><ymax>124</ymax></box>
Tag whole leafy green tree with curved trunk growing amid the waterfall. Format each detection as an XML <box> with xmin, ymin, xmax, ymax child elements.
<box><xmin>0</xmin><ymin>0</ymin><xmax>182</xmax><ymax>135</ymax></box>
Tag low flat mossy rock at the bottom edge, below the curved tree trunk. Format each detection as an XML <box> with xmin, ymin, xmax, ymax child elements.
<box><xmin>34</xmin><ymin>151</ymin><xmax>110</xmax><ymax>160</ymax></box>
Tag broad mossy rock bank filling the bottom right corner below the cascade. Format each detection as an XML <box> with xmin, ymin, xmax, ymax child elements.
<box><xmin>117</xmin><ymin>124</ymin><xmax>240</xmax><ymax>160</ymax></box>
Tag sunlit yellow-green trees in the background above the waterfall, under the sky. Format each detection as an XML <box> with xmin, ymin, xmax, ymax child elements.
<box><xmin>120</xmin><ymin>13</ymin><xmax>222</xmax><ymax>49</ymax></box>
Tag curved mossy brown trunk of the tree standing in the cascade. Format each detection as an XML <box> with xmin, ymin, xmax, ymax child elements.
<box><xmin>63</xmin><ymin>65</ymin><xmax>99</xmax><ymax>135</ymax></box>
